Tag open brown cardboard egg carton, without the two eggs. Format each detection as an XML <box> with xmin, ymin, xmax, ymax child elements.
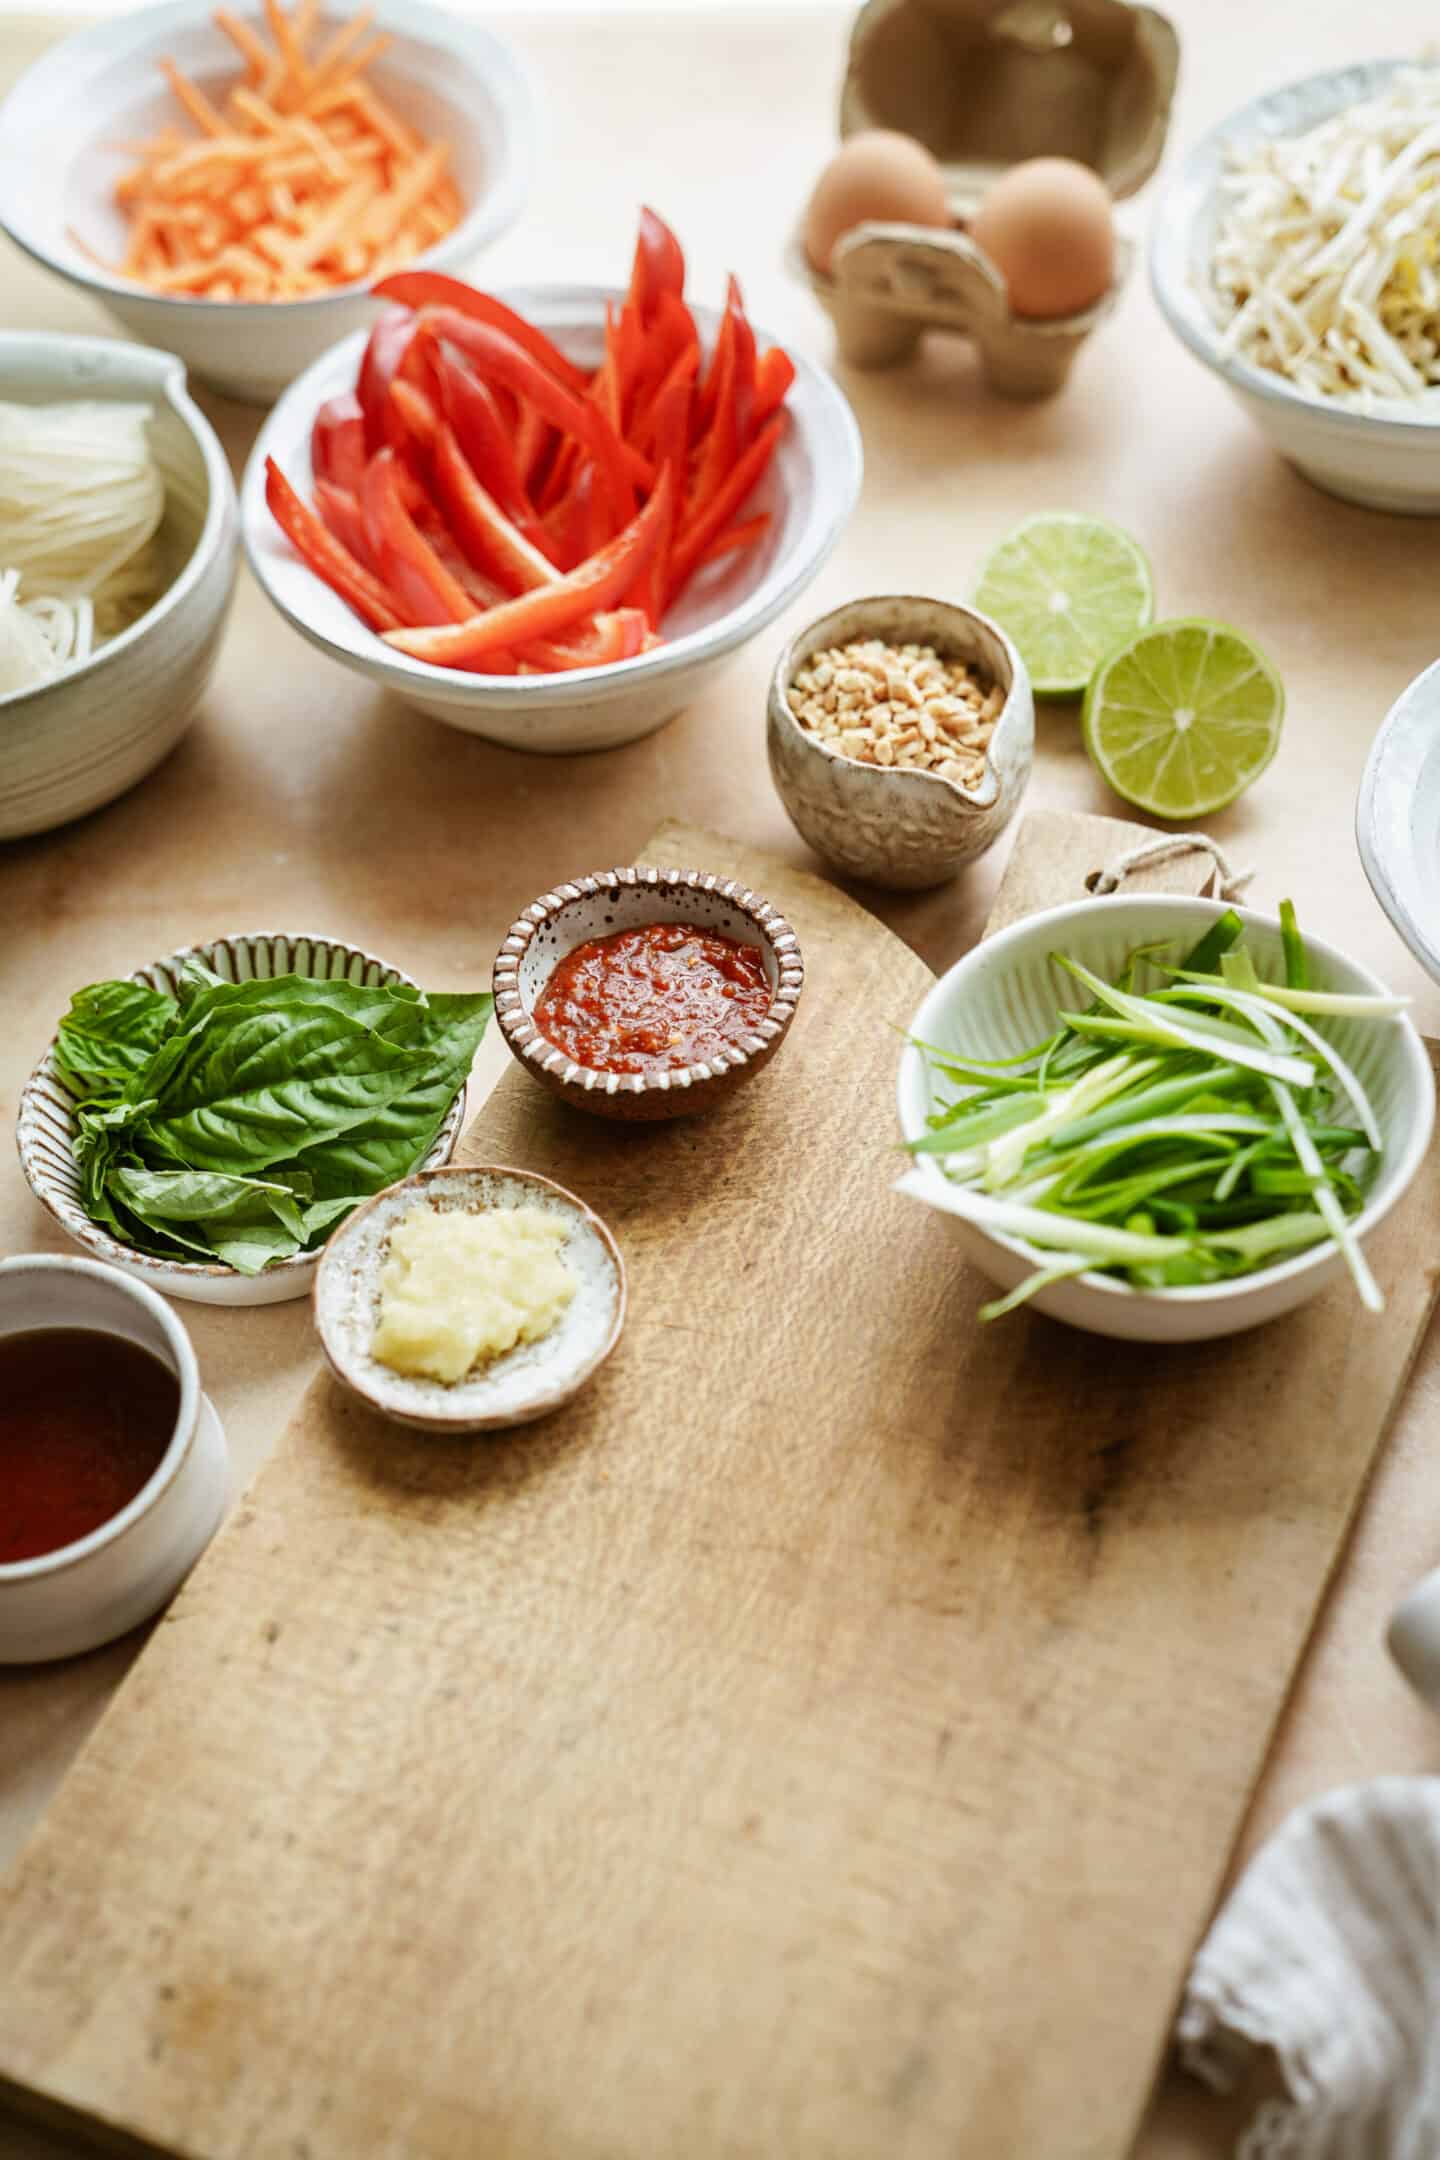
<box><xmin>790</xmin><ymin>0</ymin><xmax>1179</xmax><ymax>397</ymax></box>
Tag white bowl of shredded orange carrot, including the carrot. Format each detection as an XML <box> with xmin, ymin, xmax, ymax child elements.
<box><xmin>0</xmin><ymin>0</ymin><xmax>533</xmax><ymax>402</ymax></box>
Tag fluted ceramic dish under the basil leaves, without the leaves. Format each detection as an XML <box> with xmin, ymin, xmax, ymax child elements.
<box><xmin>15</xmin><ymin>931</ymin><xmax>464</xmax><ymax>1305</ymax></box>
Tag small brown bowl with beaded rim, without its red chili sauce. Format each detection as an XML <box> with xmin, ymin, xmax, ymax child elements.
<box><xmin>492</xmin><ymin>868</ymin><xmax>805</xmax><ymax>1121</ymax></box>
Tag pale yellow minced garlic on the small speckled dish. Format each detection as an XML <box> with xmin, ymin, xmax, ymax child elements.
<box><xmin>371</xmin><ymin>1203</ymin><xmax>574</xmax><ymax>1385</ymax></box>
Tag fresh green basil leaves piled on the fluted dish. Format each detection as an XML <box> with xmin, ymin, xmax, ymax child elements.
<box><xmin>54</xmin><ymin>961</ymin><xmax>492</xmax><ymax>1274</ymax></box>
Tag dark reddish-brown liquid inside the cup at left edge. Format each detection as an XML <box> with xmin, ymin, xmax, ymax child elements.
<box><xmin>0</xmin><ymin>1328</ymin><xmax>179</xmax><ymax>1566</ymax></box>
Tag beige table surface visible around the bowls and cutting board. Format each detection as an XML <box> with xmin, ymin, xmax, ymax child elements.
<box><xmin>0</xmin><ymin>0</ymin><xmax>1440</xmax><ymax>2160</ymax></box>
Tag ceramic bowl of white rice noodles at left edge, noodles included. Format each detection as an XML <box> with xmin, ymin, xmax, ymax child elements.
<box><xmin>0</xmin><ymin>330</ymin><xmax>240</xmax><ymax>840</ymax></box>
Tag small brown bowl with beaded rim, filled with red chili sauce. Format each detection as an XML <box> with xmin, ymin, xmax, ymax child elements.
<box><xmin>494</xmin><ymin>866</ymin><xmax>805</xmax><ymax>1121</ymax></box>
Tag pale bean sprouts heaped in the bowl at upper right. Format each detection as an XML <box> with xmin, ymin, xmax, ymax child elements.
<box><xmin>1207</xmin><ymin>67</ymin><xmax>1440</xmax><ymax>408</ymax></box>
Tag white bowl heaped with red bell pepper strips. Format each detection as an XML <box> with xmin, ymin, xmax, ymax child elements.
<box><xmin>242</xmin><ymin>214</ymin><xmax>861</xmax><ymax>752</ymax></box>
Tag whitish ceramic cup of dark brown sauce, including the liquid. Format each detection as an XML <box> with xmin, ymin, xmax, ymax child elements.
<box><xmin>0</xmin><ymin>1253</ymin><xmax>229</xmax><ymax>1665</ymax></box>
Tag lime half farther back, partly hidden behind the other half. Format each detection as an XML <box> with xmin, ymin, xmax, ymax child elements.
<box><xmin>976</xmin><ymin>510</ymin><xmax>1155</xmax><ymax>698</ymax></box>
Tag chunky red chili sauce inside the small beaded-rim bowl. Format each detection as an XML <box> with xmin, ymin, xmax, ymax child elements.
<box><xmin>535</xmin><ymin>922</ymin><xmax>771</xmax><ymax>1074</ymax></box>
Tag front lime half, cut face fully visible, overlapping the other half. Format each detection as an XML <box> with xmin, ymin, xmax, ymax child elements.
<box><xmin>1084</xmin><ymin>620</ymin><xmax>1285</xmax><ymax>819</ymax></box>
